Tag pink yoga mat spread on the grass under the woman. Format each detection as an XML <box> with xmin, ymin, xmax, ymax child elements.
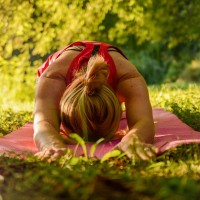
<box><xmin>0</xmin><ymin>108</ymin><xmax>200</xmax><ymax>159</ymax></box>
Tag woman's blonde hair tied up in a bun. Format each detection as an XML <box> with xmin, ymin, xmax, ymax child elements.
<box><xmin>60</xmin><ymin>55</ymin><xmax>121</xmax><ymax>141</ymax></box>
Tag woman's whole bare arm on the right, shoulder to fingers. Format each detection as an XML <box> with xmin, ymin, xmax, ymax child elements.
<box><xmin>113</xmin><ymin>55</ymin><xmax>158</xmax><ymax>160</ymax></box>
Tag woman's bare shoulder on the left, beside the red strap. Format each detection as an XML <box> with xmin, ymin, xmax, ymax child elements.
<box><xmin>41</xmin><ymin>50</ymin><xmax>80</xmax><ymax>80</ymax></box>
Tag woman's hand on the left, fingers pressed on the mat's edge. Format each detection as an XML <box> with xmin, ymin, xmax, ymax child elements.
<box><xmin>35</xmin><ymin>142</ymin><xmax>70</xmax><ymax>163</ymax></box>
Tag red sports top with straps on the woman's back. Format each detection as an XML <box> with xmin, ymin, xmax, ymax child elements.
<box><xmin>37</xmin><ymin>41</ymin><xmax>127</xmax><ymax>90</ymax></box>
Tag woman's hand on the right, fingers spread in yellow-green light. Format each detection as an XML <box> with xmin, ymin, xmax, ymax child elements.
<box><xmin>117</xmin><ymin>133</ymin><xmax>159</xmax><ymax>160</ymax></box>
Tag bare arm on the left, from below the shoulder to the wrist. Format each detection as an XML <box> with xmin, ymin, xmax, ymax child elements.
<box><xmin>34</xmin><ymin>74</ymin><xmax>66</xmax><ymax>151</ymax></box>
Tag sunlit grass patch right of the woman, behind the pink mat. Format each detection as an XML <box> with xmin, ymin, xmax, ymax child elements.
<box><xmin>149</xmin><ymin>83</ymin><xmax>200</xmax><ymax>131</ymax></box>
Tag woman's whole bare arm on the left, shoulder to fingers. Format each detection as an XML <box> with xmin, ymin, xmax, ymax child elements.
<box><xmin>34</xmin><ymin>51</ymin><xmax>75</xmax><ymax>159</ymax></box>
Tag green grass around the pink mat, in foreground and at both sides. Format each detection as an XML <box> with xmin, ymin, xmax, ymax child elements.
<box><xmin>0</xmin><ymin>84</ymin><xmax>200</xmax><ymax>200</ymax></box>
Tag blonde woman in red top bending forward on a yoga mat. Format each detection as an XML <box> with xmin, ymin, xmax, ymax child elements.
<box><xmin>34</xmin><ymin>41</ymin><xmax>158</xmax><ymax>161</ymax></box>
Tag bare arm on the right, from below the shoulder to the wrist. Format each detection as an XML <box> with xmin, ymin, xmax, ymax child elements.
<box><xmin>118</xmin><ymin>76</ymin><xmax>155</xmax><ymax>144</ymax></box>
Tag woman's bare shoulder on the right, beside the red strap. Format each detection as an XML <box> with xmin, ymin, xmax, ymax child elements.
<box><xmin>110</xmin><ymin>51</ymin><xmax>141</xmax><ymax>83</ymax></box>
